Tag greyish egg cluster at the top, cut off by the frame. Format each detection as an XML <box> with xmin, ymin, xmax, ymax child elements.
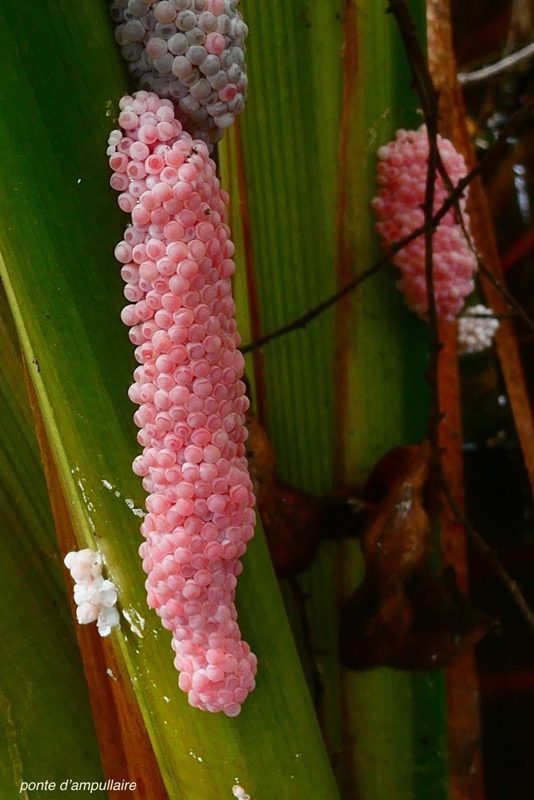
<box><xmin>110</xmin><ymin>0</ymin><xmax>248</xmax><ymax>144</ymax></box>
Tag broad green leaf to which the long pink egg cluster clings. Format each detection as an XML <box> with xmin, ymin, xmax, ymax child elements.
<box><xmin>0</xmin><ymin>0</ymin><xmax>337</xmax><ymax>800</ymax></box>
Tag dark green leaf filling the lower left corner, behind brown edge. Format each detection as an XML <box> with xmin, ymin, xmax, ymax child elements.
<box><xmin>0</xmin><ymin>288</ymin><xmax>107</xmax><ymax>800</ymax></box>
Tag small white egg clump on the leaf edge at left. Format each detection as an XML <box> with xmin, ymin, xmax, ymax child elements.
<box><xmin>64</xmin><ymin>548</ymin><xmax>119</xmax><ymax>636</ymax></box>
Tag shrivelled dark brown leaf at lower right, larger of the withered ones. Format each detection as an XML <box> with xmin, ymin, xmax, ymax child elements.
<box><xmin>339</xmin><ymin>443</ymin><xmax>491</xmax><ymax>670</ymax></box>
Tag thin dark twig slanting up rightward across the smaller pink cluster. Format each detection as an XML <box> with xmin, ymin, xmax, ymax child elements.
<box><xmin>241</xmin><ymin>101</ymin><xmax>534</xmax><ymax>353</ymax></box>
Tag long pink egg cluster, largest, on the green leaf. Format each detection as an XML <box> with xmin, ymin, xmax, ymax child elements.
<box><xmin>109</xmin><ymin>91</ymin><xmax>256</xmax><ymax>716</ymax></box>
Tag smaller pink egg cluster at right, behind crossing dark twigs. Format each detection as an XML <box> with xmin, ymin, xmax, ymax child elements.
<box><xmin>373</xmin><ymin>125</ymin><xmax>477</xmax><ymax>319</ymax></box>
